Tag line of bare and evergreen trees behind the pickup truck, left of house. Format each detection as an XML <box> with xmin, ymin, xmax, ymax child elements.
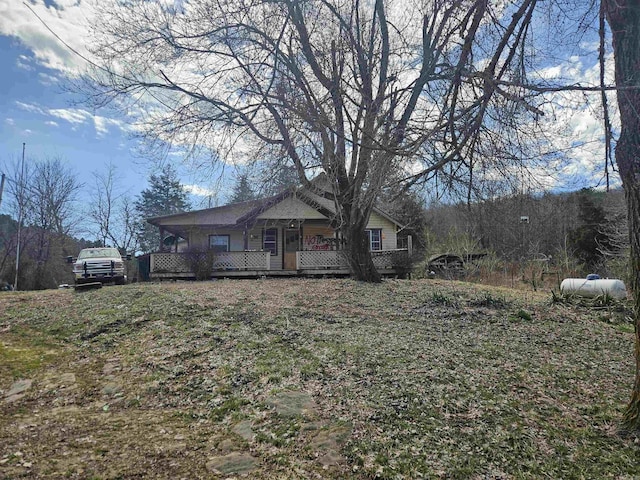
<box><xmin>0</xmin><ymin>158</ymin><xmax>190</xmax><ymax>290</ymax></box>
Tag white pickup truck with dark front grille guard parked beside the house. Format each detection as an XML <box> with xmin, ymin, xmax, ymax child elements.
<box><xmin>67</xmin><ymin>247</ymin><xmax>130</xmax><ymax>285</ymax></box>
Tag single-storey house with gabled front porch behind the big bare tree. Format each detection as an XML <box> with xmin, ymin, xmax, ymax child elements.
<box><xmin>147</xmin><ymin>179</ymin><xmax>410</xmax><ymax>279</ymax></box>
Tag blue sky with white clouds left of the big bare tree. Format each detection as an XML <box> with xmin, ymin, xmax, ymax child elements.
<box><xmin>0</xmin><ymin>0</ymin><xmax>220</xmax><ymax>217</ymax></box>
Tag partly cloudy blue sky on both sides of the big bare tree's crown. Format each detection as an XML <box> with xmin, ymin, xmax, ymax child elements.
<box><xmin>0</xmin><ymin>0</ymin><xmax>620</xmax><ymax>221</ymax></box>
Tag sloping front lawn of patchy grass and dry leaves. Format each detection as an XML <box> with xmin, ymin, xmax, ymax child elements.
<box><xmin>0</xmin><ymin>280</ymin><xmax>640</xmax><ymax>479</ymax></box>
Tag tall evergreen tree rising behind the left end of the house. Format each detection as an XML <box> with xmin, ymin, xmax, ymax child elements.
<box><xmin>135</xmin><ymin>165</ymin><xmax>190</xmax><ymax>252</ymax></box>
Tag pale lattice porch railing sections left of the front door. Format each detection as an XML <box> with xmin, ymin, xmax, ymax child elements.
<box><xmin>149</xmin><ymin>252</ymin><xmax>270</xmax><ymax>274</ymax></box>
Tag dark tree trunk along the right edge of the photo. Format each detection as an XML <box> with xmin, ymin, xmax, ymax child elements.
<box><xmin>603</xmin><ymin>0</ymin><xmax>640</xmax><ymax>432</ymax></box>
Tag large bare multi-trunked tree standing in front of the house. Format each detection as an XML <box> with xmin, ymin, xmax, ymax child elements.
<box><xmin>84</xmin><ymin>0</ymin><xmax>556</xmax><ymax>281</ymax></box>
